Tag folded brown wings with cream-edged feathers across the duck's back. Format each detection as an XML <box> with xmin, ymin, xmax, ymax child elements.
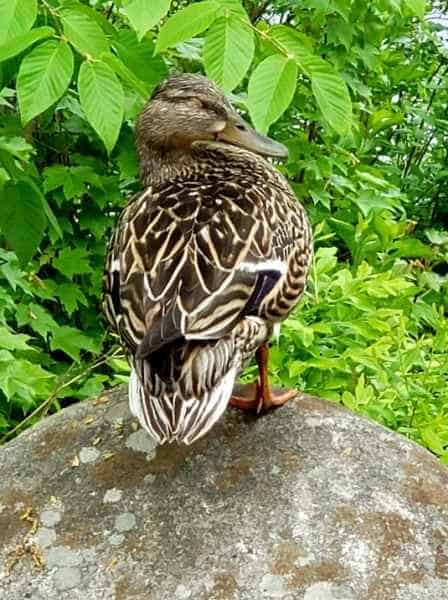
<box><xmin>106</xmin><ymin>180</ymin><xmax>306</xmax><ymax>357</ymax></box>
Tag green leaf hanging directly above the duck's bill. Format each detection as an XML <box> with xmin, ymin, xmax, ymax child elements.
<box><xmin>248</xmin><ymin>54</ymin><xmax>297</xmax><ymax>133</ymax></box>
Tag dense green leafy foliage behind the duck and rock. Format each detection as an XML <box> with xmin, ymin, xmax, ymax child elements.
<box><xmin>0</xmin><ymin>0</ymin><xmax>448</xmax><ymax>463</ymax></box>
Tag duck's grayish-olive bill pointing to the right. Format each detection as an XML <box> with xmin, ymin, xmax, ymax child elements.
<box><xmin>217</xmin><ymin>115</ymin><xmax>288</xmax><ymax>158</ymax></box>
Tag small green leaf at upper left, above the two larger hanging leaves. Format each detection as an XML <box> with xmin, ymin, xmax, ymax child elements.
<box><xmin>61</xmin><ymin>8</ymin><xmax>109</xmax><ymax>58</ymax></box>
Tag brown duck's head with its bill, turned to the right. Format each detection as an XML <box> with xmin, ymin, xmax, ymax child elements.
<box><xmin>137</xmin><ymin>74</ymin><xmax>288</xmax><ymax>157</ymax></box>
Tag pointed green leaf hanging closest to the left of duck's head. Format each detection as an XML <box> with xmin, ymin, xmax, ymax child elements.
<box><xmin>78</xmin><ymin>62</ymin><xmax>124</xmax><ymax>153</ymax></box>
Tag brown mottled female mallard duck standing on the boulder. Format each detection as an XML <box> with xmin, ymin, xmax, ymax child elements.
<box><xmin>105</xmin><ymin>75</ymin><xmax>311</xmax><ymax>444</ymax></box>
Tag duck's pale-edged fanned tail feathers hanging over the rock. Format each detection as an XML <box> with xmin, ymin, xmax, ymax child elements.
<box><xmin>129</xmin><ymin>317</ymin><xmax>270</xmax><ymax>444</ymax></box>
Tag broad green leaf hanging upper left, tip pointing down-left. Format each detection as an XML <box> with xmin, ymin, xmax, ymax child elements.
<box><xmin>17</xmin><ymin>40</ymin><xmax>73</xmax><ymax>125</ymax></box>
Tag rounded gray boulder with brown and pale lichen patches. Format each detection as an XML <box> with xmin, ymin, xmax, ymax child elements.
<box><xmin>0</xmin><ymin>390</ymin><xmax>448</xmax><ymax>600</ymax></box>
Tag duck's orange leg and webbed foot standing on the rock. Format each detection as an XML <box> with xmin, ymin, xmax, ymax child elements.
<box><xmin>229</xmin><ymin>344</ymin><xmax>297</xmax><ymax>414</ymax></box>
